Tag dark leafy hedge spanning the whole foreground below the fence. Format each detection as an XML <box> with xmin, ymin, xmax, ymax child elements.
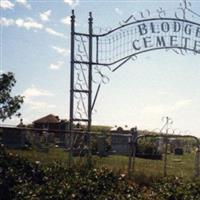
<box><xmin>0</xmin><ymin>145</ymin><xmax>200</xmax><ymax>200</ymax></box>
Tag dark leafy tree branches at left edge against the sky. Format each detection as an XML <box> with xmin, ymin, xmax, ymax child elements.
<box><xmin>0</xmin><ymin>72</ymin><xmax>24</xmax><ymax>121</ymax></box>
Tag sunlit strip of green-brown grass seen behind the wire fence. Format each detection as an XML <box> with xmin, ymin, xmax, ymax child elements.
<box><xmin>7</xmin><ymin>148</ymin><xmax>195</xmax><ymax>178</ymax></box>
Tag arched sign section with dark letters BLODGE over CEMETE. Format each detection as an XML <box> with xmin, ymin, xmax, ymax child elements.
<box><xmin>132</xmin><ymin>19</ymin><xmax>200</xmax><ymax>54</ymax></box>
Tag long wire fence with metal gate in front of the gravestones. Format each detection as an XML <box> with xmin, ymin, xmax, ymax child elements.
<box><xmin>0</xmin><ymin>127</ymin><xmax>200</xmax><ymax>177</ymax></box>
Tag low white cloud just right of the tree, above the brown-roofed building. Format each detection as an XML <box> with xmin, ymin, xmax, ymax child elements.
<box><xmin>22</xmin><ymin>85</ymin><xmax>53</xmax><ymax>99</ymax></box>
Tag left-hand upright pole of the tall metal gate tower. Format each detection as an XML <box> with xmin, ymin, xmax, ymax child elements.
<box><xmin>69</xmin><ymin>10</ymin><xmax>75</xmax><ymax>165</ymax></box>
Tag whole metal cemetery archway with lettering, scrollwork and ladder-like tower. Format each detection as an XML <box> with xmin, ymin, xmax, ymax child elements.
<box><xmin>70</xmin><ymin>0</ymin><xmax>200</xmax><ymax>131</ymax></box>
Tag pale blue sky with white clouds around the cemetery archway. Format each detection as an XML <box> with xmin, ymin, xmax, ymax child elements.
<box><xmin>0</xmin><ymin>0</ymin><xmax>200</xmax><ymax>136</ymax></box>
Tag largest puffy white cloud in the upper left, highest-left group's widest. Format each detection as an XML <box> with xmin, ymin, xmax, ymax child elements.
<box><xmin>15</xmin><ymin>17</ymin><xmax>43</xmax><ymax>30</ymax></box>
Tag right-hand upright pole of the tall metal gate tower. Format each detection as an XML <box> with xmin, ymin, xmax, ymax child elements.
<box><xmin>87</xmin><ymin>12</ymin><xmax>93</xmax><ymax>132</ymax></box>
